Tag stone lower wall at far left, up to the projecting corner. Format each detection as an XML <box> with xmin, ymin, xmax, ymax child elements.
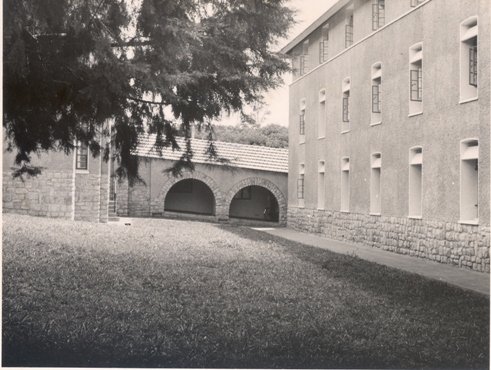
<box><xmin>2</xmin><ymin>170</ymin><xmax>73</xmax><ymax>219</ymax></box>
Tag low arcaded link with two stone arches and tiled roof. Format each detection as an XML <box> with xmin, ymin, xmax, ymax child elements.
<box><xmin>116</xmin><ymin>138</ymin><xmax>288</xmax><ymax>225</ymax></box>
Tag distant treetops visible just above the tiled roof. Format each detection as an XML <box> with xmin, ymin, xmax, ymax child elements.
<box><xmin>196</xmin><ymin>124</ymin><xmax>288</xmax><ymax>148</ymax></box>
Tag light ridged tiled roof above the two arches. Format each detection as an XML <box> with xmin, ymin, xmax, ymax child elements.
<box><xmin>133</xmin><ymin>135</ymin><xmax>288</xmax><ymax>173</ymax></box>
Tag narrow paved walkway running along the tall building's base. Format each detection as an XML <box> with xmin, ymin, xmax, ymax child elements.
<box><xmin>254</xmin><ymin>228</ymin><xmax>490</xmax><ymax>296</ymax></box>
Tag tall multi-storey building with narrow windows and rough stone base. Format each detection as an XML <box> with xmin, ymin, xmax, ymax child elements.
<box><xmin>283</xmin><ymin>0</ymin><xmax>491</xmax><ymax>272</ymax></box>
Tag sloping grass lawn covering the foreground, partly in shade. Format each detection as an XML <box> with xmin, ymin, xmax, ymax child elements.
<box><xmin>3</xmin><ymin>214</ymin><xmax>489</xmax><ymax>368</ymax></box>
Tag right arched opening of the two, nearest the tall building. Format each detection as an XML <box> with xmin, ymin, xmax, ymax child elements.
<box><xmin>229</xmin><ymin>185</ymin><xmax>279</xmax><ymax>222</ymax></box>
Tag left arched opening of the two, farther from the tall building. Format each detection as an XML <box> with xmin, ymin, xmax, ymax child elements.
<box><xmin>164</xmin><ymin>179</ymin><xmax>215</xmax><ymax>215</ymax></box>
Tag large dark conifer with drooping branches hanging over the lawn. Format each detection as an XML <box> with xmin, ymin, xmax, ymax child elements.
<box><xmin>3</xmin><ymin>0</ymin><xmax>293</xmax><ymax>181</ymax></box>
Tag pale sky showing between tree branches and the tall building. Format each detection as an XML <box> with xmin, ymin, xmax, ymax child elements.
<box><xmin>219</xmin><ymin>0</ymin><xmax>337</xmax><ymax>126</ymax></box>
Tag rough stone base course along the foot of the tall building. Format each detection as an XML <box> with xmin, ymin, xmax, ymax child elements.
<box><xmin>288</xmin><ymin>207</ymin><xmax>490</xmax><ymax>273</ymax></box>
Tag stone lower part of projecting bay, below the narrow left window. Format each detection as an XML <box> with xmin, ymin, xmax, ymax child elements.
<box><xmin>75</xmin><ymin>173</ymin><xmax>100</xmax><ymax>222</ymax></box>
